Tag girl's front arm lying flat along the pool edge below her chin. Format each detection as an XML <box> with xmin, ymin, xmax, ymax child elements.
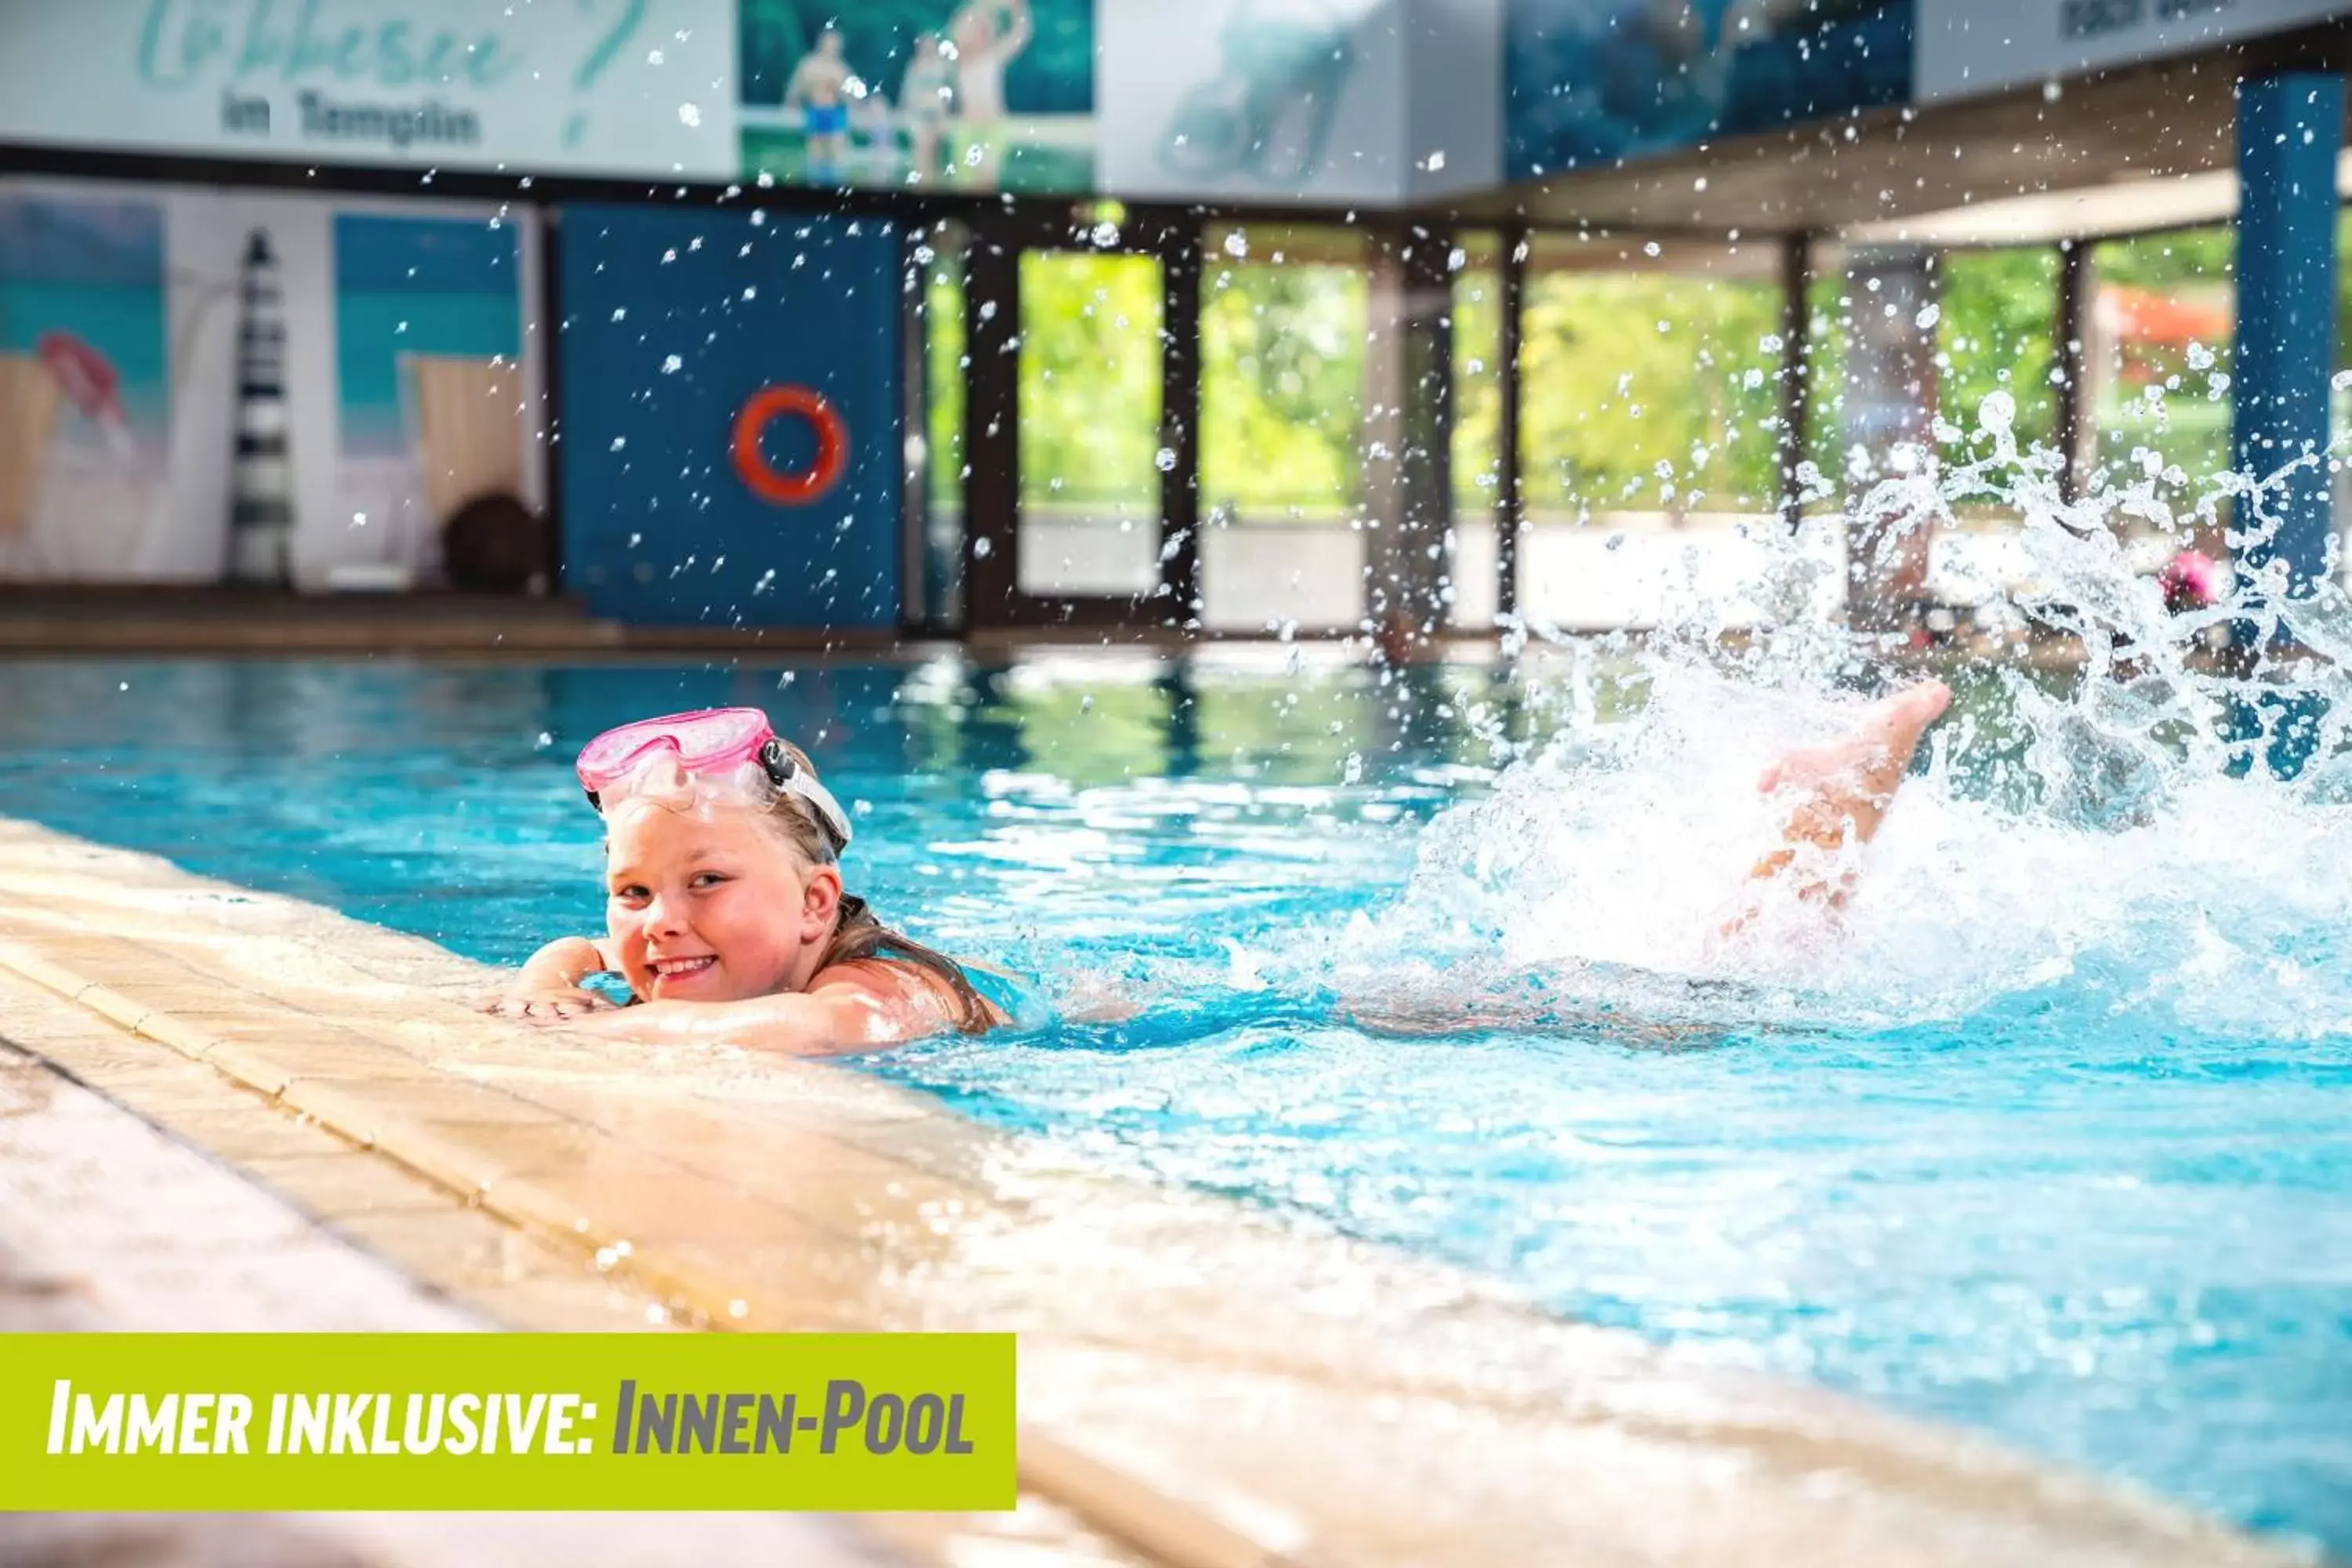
<box><xmin>532</xmin><ymin>961</ymin><xmax>950</xmax><ymax>1055</ymax></box>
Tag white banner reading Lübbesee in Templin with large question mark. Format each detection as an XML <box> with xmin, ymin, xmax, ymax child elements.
<box><xmin>0</xmin><ymin>0</ymin><xmax>736</xmax><ymax>179</ymax></box>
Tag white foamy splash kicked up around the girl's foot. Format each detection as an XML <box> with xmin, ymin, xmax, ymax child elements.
<box><xmin>1289</xmin><ymin>395</ymin><xmax>2352</xmax><ymax>1039</ymax></box>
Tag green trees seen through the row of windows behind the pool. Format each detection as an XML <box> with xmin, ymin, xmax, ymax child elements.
<box><xmin>969</xmin><ymin>228</ymin><xmax>2277</xmax><ymax>524</ymax></box>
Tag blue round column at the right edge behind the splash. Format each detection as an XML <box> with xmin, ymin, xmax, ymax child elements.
<box><xmin>2230</xmin><ymin>71</ymin><xmax>2345</xmax><ymax>597</ymax></box>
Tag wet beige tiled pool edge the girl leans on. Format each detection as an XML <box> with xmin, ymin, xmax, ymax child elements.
<box><xmin>0</xmin><ymin>818</ymin><xmax>2296</xmax><ymax>1568</ymax></box>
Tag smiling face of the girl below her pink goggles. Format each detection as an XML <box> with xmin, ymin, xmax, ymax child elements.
<box><xmin>604</xmin><ymin>794</ymin><xmax>842</xmax><ymax>1001</ymax></box>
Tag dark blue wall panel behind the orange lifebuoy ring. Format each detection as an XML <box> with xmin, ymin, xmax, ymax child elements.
<box><xmin>557</xmin><ymin>205</ymin><xmax>903</xmax><ymax>628</ymax></box>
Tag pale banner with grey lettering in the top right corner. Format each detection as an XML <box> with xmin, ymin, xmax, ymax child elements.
<box><xmin>1915</xmin><ymin>0</ymin><xmax>2343</xmax><ymax>103</ymax></box>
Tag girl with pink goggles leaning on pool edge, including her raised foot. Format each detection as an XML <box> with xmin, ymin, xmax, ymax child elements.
<box><xmin>487</xmin><ymin>682</ymin><xmax>1952</xmax><ymax>1055</ymax></box>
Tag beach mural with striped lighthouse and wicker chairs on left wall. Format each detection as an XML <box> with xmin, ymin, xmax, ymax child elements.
<box><xmin>0</xmin><ymin>176</ymin><xmax>546</xmax><ymax>593</ymax></box>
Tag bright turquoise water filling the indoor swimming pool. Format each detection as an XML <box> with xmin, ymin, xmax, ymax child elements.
<box><xmin>0</xmin><ymin>659</ymin><xmax>2352</xmax><ymax>1552</ymax></box>
